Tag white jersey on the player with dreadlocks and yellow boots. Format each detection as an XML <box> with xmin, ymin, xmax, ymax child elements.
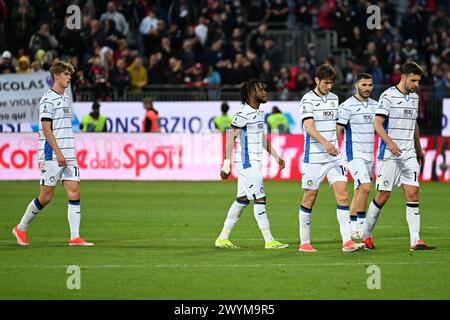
<box><xmin>231</xmin><ymin>104</ymin><xmax>264</xmax><ymax>169</ymax></box>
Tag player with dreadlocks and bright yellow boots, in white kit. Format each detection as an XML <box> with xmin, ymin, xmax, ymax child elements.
<box><xmin>215</xmin><ymin>79</ymin><xmax>288</xmax><ymax>249</ymax></box>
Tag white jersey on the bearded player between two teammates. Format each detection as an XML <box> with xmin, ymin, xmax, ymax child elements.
<box><xmin>337</xmin><ymin>96</ymin><xmax>377</xmax><ymax>162</ymax></box>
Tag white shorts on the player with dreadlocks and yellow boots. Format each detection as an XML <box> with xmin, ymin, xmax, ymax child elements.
<box><xmin>236</xmin><ymin>167</ymin><xmax>266</xmax><ymax>200</ymax></box>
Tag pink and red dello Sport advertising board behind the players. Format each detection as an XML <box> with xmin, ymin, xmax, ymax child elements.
<box><xmin>0</xmin><ymin>133</ymin><xmax>450</xmax><ymax>182</ymax></box>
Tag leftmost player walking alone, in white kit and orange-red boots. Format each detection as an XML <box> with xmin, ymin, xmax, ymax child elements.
<box><xmin>12</xmin><ymin>60</ymin><xmax>94</xmax><ymax>246</ymax></box>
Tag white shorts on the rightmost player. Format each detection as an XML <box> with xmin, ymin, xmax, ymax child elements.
<box><xmin>377</xmin><ymin>158</ymin><xmax>420</xmax><ymax>191</ymax></box>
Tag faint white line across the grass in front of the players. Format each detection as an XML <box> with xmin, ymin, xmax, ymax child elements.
<box><xmin>0</xmin><ymin>260</ymin><xmax>449</xmax><ymax>269</ymax></box>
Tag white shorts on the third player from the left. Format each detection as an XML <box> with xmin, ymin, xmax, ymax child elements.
<box><xmin>302</xmin><ymin>161</ymin><xmax>347</xmax><ymax>190</ymax></box>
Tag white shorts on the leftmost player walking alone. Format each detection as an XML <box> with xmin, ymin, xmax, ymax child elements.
<box><xmin>40</xmin><ymin>160</ymin><xmax>80</xmax><ymax>187</ymax></box>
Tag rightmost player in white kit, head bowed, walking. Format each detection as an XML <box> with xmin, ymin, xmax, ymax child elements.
<box><xmin>363</xmin><ymin>62</ymin><xmax>434</xmax><ymax>250</ymax></box>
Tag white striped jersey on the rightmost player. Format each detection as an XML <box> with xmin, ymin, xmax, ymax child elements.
<box><xmin>376</xmin><ymin>86</ymin><xmax>419</xmax><ymax>161</ymax></box>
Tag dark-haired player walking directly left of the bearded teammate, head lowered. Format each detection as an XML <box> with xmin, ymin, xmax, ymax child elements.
<box><xmin>299</xmin><ymin>64</ymin><xmax>361</xmax><ymax>252</ymax></box>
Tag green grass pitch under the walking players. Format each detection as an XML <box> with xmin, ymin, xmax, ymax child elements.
<box><xmin>0</xmin><ymin>181</ymin><xmax>450</xmax><ymax>300</ymax></box>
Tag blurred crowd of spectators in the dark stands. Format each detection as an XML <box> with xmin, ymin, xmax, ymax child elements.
<box><xmin>0</xmin><ymin>0</ymin><xmax>450</xmax><ymax>100</ymax></box>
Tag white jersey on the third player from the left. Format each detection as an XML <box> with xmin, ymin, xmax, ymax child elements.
<box><xmin>300</xmin><ymin>90</ymin><xmax>341</xmax><ymax>163</ymax></box>
